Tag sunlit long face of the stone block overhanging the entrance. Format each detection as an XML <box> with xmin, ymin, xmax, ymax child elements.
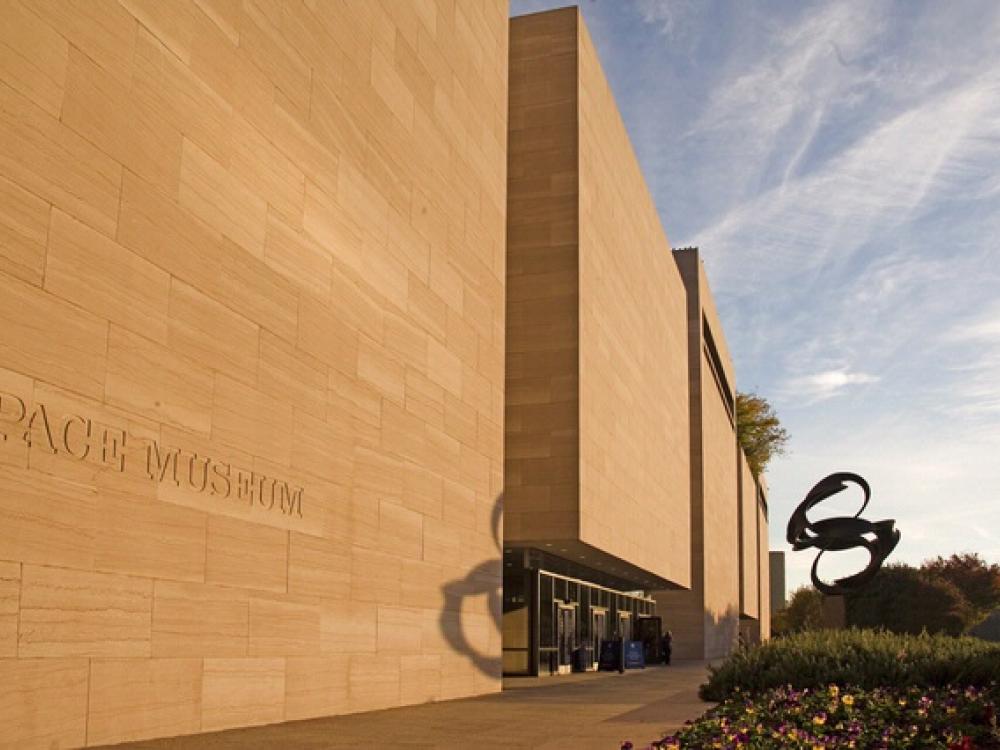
<box><xmin>578</xmin><ymin>13</ymin><xmax>691</xmax><ymax>586</ymax></box>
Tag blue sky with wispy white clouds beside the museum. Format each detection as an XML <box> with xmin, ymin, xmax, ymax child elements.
<box><xmin>511</xmin><ymin>0</ymin><xmax>1000</xmax><ymax>590</ymax></box>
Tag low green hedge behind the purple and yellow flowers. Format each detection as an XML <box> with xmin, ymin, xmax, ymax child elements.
<box><xmin>700</xmin><ymin>629</ymin><xmax>1000</xmax><ymax>701</ymax></box>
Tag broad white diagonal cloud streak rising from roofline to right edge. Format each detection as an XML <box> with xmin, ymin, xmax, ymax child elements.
<box><xmin>694</xmin><ymin>69</ymin><xmax>1000</xmax><ymax>291</ymax></box>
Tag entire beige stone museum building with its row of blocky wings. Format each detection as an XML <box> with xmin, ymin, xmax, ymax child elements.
<box><xmin>0</xmin><ymin>0</ymin><xmax>767</xmax><ymax>748</ymax></box>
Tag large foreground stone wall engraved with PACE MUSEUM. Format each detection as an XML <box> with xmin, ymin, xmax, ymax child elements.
<box><xmin>0</xmin><ymin>0</ymin><xmax>508</xmax><ymax>748</ymax></box>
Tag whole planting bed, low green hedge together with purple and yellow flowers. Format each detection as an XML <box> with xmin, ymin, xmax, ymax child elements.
<box><xmin>623</xmin><ymin>630</ymin><xmax>1000</xmax><ymax>750</ymax></box>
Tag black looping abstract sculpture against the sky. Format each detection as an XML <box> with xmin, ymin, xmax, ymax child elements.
<box><xmin>787</xmin><ymin>472</ymin><xmax>900</xmax><ymax>595</ymax></box>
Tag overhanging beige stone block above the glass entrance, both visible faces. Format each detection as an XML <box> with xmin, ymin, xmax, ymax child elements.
<box><xmin>505</xmin><ymin>8</ymin><xmax>690</xmax><ymax>585</ymax></box>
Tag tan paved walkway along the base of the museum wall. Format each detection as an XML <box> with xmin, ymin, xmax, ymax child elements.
<box><xmin>118</xmin><ymin>661</ymin><xmax>710</xmax><ymax>750</ymax></box>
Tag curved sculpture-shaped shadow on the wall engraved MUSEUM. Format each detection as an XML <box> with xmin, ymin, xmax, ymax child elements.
<box><xmin>438</xmin><ymin>494</ymin><xmax>503</xmax><ymax>679</ymax></box>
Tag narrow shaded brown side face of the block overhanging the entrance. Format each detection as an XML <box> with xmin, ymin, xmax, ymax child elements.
<box><xmin>504</xmin><ymin>8</ymin><xmax>580</xmax><ymax>544</ymax></box>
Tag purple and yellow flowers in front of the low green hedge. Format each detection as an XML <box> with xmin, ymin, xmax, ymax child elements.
<box><xmin>652</xmin><ymin>683</ymin><xmax>1000</xmax><ymax>750</ymax></box>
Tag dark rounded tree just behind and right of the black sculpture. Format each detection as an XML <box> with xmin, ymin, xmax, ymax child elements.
<box><xmin>845</xmin><ymin>563</ymin><xmax>971</xmax><ymax>635</ymax></box>
